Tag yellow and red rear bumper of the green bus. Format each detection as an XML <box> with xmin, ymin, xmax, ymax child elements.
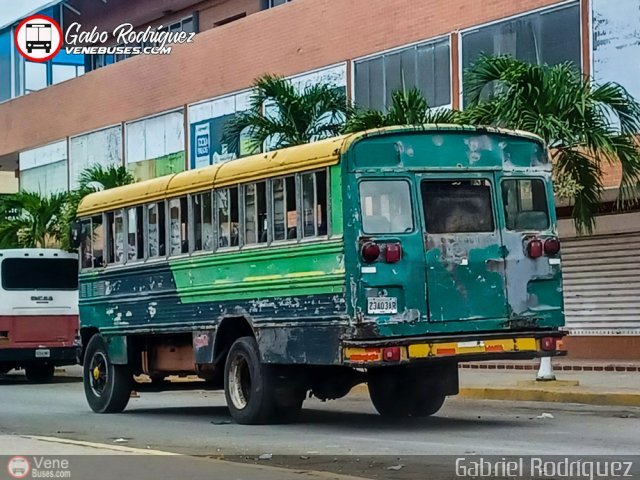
<box><xmin>342</xmin><ymin>330</ymin><xmax>566</xmax><ymax>367</ymax></box>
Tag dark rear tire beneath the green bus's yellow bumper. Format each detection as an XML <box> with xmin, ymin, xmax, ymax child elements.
<box><xmin>368</xmin><ymin>369</ymin><xmax>446</xmax><ymax>418</ymax></box>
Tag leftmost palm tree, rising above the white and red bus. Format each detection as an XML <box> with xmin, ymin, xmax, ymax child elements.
<box><xmin>0</xmin><ymin>192</ymin><xmax>68</xmax><ymax>248</ymax></box>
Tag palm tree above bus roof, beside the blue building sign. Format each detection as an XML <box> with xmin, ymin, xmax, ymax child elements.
<box><xmin>223</xmin><ymin>75</ymin><xmax>347</xmax><ymax>153</ymax></box>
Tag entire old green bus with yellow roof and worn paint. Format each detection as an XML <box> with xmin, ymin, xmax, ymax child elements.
<box><xmin>76</xmin><ymin>125</ymin><xmax>564</xmax><ymax>424</ymax></box>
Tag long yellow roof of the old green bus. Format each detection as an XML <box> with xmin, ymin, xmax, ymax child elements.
<box><xmin>78</xmin><ymin>125</ymin><xmax>543</xmax><ymax>217</ymax></box>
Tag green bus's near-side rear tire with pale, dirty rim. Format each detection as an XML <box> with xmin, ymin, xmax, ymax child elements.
<box><xmin>224</xmin><ymin>337</ymin><xmax>286</xmax><ymax>425</ymax></box>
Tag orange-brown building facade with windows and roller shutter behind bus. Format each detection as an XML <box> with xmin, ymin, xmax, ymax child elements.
<box><xmin>0</xmin><ymin>0</ymin><xmax>640</xmax><ymax>359</ymax></box>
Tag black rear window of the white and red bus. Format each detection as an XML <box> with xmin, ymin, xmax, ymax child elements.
<box><xmin>1</xmin><ymin>258</ymin><xmax>78</xmax><ymax>290</ymax></box>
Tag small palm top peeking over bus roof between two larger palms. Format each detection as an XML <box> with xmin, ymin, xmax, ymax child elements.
<box><xmin>344</xmin><ymin>87</ymin><xmax>460</xmax><ymax>133</ymax></box>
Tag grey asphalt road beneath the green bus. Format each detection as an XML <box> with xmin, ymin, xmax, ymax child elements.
<box><xmin>0</xmin><ymin>373</ymin><xmax>640</xmax><ymax>479</ymax></box>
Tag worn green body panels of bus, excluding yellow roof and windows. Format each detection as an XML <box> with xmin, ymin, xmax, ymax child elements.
<box><xmin>79</xmin><ymin>127</ymin><xmax>564</xmax><ymax>420</ymax></box>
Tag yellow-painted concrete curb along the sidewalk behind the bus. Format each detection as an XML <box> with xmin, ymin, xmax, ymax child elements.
<box><xmin>351</xmin><ymin>384</ymin><xmax>640</xmax><ymax>407</ymax></box>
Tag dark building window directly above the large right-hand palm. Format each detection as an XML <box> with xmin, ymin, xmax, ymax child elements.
<box><xmin>462</xmin><ymin>2</ymin><xmax>582</xmax><ymax>103</ymax></box>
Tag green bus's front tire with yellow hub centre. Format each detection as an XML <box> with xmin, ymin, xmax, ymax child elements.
<box><xmin>82</xmin><ymin>335</ymin><xmax>133</xmax><ymax>413</ymax></box>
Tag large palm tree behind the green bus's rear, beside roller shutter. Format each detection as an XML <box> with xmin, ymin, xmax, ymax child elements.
<box><xmin>464</xmin><ymin>56</ymin><xmax>640</xmax><ymax>232</ymax></box>
